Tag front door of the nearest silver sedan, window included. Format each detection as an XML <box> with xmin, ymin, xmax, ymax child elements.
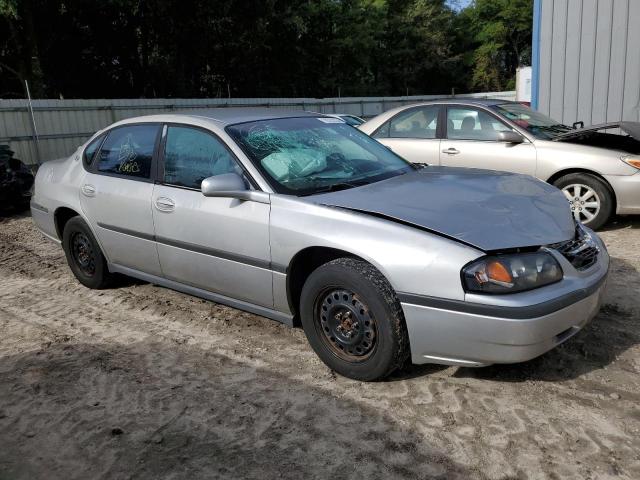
<box><xmin>152</xmin><ymin>125</ymin><xmax>273</xmax><ymax>307</ymax></box>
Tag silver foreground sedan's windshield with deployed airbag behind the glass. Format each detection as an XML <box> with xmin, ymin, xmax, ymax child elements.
<box><xmin>227</xmin><ymin>117</ymin><xmax>414</xmax><ymax>195</ymax></box>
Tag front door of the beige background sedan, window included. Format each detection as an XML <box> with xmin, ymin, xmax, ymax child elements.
<box><xmin>440</xmin><ymin>105</ymin><xmax>536</xmax><ymax>175</ymax></box>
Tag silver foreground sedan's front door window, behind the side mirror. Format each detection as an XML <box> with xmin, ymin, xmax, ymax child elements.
<box><xmin>164</xmin><ymin>126</ymin><xmax>242</xmax><ymax>189</ymax></box>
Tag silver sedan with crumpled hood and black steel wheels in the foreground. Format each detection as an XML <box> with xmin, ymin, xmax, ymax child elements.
<box><xmin>31</xmin><ymin>109</ymin><xmax>609</xmax><ymax>380</ymax></box>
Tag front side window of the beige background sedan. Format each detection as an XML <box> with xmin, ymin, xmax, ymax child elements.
<box><xmin>447</xmin><ymin>107</ymin><xmax>512</xmax><ymax>141</ymax></box>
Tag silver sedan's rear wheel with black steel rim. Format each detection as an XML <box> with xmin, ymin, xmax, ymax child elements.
<box><xmin>62</xmin><ymin>217</ymin><xmax>113</xmax><ymax>289</ymax></box>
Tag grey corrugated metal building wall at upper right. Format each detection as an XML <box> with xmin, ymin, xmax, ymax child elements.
<box><xmin>534</xmin><ymin>0</ymin><xmax>640</xmax><ymax>125</ymax></box>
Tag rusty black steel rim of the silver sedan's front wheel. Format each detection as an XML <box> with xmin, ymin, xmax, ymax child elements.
<box><xmin>315</xmin><ymin>287</ymin><xmax>378</xmax><ymax>363</ymax></box>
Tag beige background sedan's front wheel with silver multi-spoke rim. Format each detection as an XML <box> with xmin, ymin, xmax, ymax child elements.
<box><xmin>554</xmin><ymin>173</ymin><xmax>614</xmax><ymax>230</ymax></box>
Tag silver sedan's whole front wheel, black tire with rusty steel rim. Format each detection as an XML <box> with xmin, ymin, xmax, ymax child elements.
<box><xmin>300</xmin><ymin>258</ymin><xmax>410</xmax><ymax>381</ymax></box>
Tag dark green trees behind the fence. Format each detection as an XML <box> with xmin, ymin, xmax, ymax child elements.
<box><xmin>0</xmin><ymin>0</ymin><xmax>532</xmax><ymax>98</ymax></box>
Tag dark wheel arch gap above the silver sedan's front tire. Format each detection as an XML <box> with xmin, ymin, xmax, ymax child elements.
<box><xmin>287</xmin><ymin>246</ymin><xmax>391</xmax><ymax>327</ymax></box>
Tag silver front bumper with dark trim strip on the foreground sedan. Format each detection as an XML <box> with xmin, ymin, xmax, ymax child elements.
<box><xmin>400</xmin><ymin>234</ymin><xmax>609</xmax><ymax>367</ymax></box>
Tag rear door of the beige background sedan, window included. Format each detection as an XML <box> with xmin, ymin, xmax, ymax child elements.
<box><xmin>373</xmin><ymin>105</ymin><xmax>440</xmax><ymax>165</ymax></box>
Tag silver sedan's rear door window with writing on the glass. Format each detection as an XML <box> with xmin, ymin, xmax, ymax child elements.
<box><xmin>97</xmin><ymin>125</ymin><xmax>160</xmax><ymax>179</ymax></box>
